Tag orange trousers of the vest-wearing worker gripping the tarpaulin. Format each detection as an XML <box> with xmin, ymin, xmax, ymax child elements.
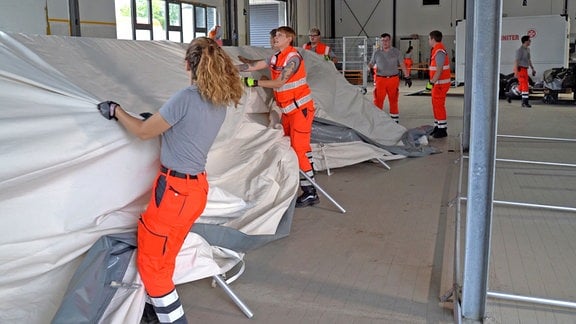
<box><xmin>282</xmin><ymin>100</ymin><xmax>314</xmax><ymax>172</ymax></box>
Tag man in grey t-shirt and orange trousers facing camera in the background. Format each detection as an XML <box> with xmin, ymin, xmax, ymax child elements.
<box><xmin>368</xmin><ymin>33</ymin><xmax>412</xmax><ymax>123</ymax></box>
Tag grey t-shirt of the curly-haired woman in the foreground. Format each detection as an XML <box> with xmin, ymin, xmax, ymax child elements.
<box><xmin>159</xmin><ymin>85</ymin><xmax>226</xmax><ymax>174</ymax></box>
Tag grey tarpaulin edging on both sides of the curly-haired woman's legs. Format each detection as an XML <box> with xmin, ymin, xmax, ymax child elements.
<box><xmin>52</xmin><ymin>199</ymin><xmax>296</xmax><ymax>324</ymax></box>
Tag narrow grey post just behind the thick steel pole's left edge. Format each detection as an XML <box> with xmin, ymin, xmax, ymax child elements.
<box><xmin>462</xmin><ymin>0</ymin><xmax>475</xmax><ymax>152</ymax></box>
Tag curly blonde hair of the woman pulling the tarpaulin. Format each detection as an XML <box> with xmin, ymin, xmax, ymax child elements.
<box><xmin>184</xmin><ymin>37</ymin><xmax>244</xmax><ymax>106</ymax></box>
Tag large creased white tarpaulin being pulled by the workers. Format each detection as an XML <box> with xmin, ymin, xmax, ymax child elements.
<box><xmin>0</xmin><ymin>32</ymin><xmax>414</xmax><ymax>323</ymax></box>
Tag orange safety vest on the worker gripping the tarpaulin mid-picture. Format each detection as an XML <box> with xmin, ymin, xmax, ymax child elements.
<box><xmin>270</xmin><ymin>46</ymin><xmax>312</xmax><ymax>114</ymax></box>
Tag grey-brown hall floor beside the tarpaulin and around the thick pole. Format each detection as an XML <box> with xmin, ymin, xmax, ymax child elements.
<box><xmin>178</xmin><ymin>81</ymin><xmax>576</xmax><ymax>324</ymax></box>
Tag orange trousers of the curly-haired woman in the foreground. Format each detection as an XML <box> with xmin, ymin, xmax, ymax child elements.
<box><xmin>137</xmin><ymin>168</ymin><xmax>208</xmax><ymax>297</ymax></box>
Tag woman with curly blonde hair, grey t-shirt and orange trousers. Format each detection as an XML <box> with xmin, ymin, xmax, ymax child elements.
<box><xmin>98</xmin><ymin>37</ymin><xmax>244</xmax><ymax>323</ymax></box>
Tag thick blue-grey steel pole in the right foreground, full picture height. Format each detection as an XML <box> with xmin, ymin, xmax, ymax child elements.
<box><xmin>462</xmin><ymin>0</ymin><xmax>502</xmax><ymax>321</ymax></box>
